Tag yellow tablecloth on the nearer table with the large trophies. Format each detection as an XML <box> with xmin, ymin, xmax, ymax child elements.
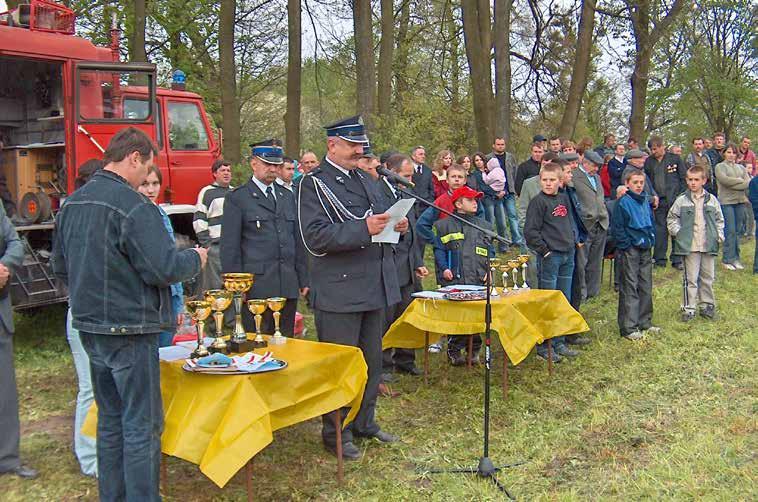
<box><xmin>82</xmin><ymin>339</ymin><xmax>368</xmax><ymax>487</ymax></box>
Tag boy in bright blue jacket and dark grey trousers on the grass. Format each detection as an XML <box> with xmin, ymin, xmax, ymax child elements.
<box><xmin>611</xmin><ymin>170</ymin><xmax>661</xmax><ymax>340</ymax></box>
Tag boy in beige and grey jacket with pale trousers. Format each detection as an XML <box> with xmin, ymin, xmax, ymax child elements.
<box><xmin>667</xmin><ymin>166</ymin><xmax>724</xmax><ymax>322</ymax></box>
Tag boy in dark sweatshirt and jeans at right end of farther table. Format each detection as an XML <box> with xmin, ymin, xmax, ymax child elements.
<box><xmin>524</xmin><ymin>162</ymin><xmax>578</xmax><ymax>362</ymax></box>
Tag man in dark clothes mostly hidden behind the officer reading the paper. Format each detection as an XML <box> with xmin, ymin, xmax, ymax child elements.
<box><xmin>379</xmin><ymin>153</ymin><xmax>429</xmax><ymax>375</ymax></box>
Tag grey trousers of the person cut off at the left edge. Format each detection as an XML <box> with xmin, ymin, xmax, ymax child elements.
<box><xmin>0</xmin><ymin>325</ymin><xmax>20</xmax><ymax>473</ymax></box>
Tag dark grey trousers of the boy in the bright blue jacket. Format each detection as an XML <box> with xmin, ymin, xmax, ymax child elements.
<box><xmin>616</xmin><ymin>246</ymin><xmax>653</xmax><ymax>336</ymax></box>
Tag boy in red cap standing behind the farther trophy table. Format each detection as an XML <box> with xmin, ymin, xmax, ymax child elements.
<box><xmin>432</xmin><ymin>186</ymin><xmax>495</xmax><ymax>366</ymax></box>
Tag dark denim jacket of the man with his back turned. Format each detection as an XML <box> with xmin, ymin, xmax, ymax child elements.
<box><xmin>52</xmin><ymin>170</ymin><xmax>200</xmax><ymax>335</ymax></box>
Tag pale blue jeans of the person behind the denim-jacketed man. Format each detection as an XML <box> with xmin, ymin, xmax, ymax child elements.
<box><xmin>66</xmin><ymin>309</ymin><xmax>97</xmax><ymax>476</ymax></box>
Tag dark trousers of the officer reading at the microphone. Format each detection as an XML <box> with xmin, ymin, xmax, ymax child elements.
<box><xmin>313</xmin><ymin>309</ymin><xmax>385</xmax><ymax>447</ymax></box>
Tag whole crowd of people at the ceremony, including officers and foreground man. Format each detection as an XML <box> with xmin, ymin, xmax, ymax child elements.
<box><xmin>0</xmin><ymin>117</ymin><xmax>758</xmax><ymax>500</ymax></box>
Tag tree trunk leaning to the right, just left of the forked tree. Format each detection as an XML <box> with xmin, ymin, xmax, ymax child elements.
<box><xmin>558</xmin><ymin>0</ymin><xmax>595</xmax><ymax>138</ymax></box>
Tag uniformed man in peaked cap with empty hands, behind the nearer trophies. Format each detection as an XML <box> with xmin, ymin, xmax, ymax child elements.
<box><xmin>221</xmin><ymin>140</ymin><xmax>308</xmax><ymax>337</ymax></box>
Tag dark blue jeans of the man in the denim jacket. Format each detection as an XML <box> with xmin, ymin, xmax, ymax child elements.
<box><xmin>81</xmin><ymin>333</ymin><xmax>163</xmax><ymax>502</ymax></box>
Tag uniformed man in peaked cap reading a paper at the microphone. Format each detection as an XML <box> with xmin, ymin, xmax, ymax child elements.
<box><xmin>298</xmin><ymin>116</ymin><xmax>408</xmax><ymax>459</ymax></box>
